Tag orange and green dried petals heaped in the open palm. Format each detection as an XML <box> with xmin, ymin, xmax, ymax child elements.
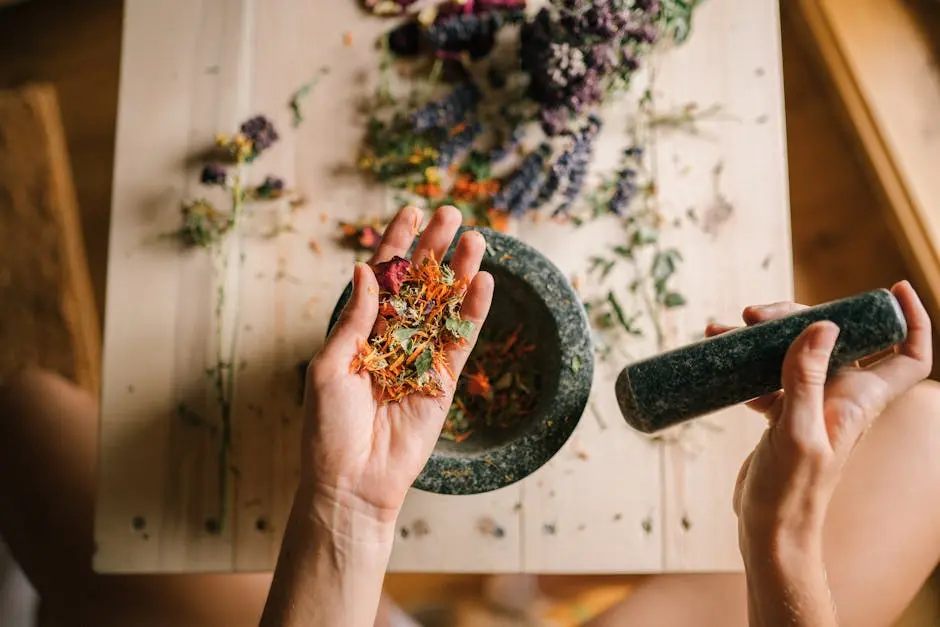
<box><xmin>351</xmin><ymin>256</ymin><xmax>474</xmax><ymax>402</ymax></box>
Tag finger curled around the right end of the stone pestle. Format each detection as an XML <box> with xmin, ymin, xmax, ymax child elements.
<box><xmin>868</xmin><ymin>281</ymin><xmax>933</xmax><ymax>388</ymax></box>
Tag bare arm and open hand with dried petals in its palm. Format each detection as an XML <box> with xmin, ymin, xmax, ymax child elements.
<box><xmin>261</xmin><ymin>207</ymin><xmax>493</xmax><ymax>627</ymax></box>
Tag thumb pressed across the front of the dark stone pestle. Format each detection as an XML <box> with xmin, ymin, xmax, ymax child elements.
<box><xmin>778</xmin><ymin>321</ymin><xmax>839</xmax><ymax>445</ymax></box>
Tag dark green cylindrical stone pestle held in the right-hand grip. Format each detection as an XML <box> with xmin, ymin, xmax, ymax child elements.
<box><xmin>616</xmin><ymin>289</ymin><xmax>907</xmax><ymax>433</ymax></box>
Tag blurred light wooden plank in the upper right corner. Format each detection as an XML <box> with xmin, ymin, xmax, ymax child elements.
<box><xmin>791</xmin><ymin>0</ymin><xmax>940</xmax><ymax>318</ymax></box>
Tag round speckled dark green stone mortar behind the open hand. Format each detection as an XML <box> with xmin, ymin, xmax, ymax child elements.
<box><xmin>329</xmin><ymin>227</ymin><xmax>594</xmax><ymax>494</ymax></box>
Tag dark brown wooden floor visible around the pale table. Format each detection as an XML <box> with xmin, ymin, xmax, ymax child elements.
<box><xmin>0</xmin><ymin>0</ymin><xmax>924</xmax><ymax>620</ymax></box>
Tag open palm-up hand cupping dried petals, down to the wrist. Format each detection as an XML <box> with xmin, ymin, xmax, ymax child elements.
<box><xmin>301</xmin><ymin>207</ymin><xmax>493</xmax><ymax>523</ymax></box>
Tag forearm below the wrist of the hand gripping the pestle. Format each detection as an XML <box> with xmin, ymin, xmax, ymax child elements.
<box><xmin>744</xmin><ymin>538</ymin><xmax>838</xmax><ymax>627</ymax></box>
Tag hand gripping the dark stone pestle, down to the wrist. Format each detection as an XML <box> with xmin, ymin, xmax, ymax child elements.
<box><xmin>706</xmin><ymin>281</ymin><xmax>932</xmax><ymax>560</ymax></box>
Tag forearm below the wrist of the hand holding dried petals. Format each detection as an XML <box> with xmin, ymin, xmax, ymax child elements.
<box><xmin>261</xmin><ymin>488</ymin><xmax>394</xmax><ymax>627</ymax></box>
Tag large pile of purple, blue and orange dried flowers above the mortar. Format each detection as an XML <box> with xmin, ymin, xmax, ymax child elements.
<box><xmin>360</xmin><ymin>0</ymin><xmax>696</xmax><ymax>226</ymax></box>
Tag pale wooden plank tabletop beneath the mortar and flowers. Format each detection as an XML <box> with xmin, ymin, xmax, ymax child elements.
<box><xmin>95</xmin><ymin>0</ymin><xmax>792</xmax><ymax>572</ymax></box>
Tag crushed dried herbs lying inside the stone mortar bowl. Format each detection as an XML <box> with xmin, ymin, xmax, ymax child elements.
<box><xmin>441</xmin><ymin>326</ymin><xmax>540</xmax><ymax>442</ymax></box>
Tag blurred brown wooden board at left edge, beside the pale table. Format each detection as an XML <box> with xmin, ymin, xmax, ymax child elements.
<box><xmin>0</xmin><ymin>84</ymin><xmax>101</xmax><ymax>394</ymax></box>
